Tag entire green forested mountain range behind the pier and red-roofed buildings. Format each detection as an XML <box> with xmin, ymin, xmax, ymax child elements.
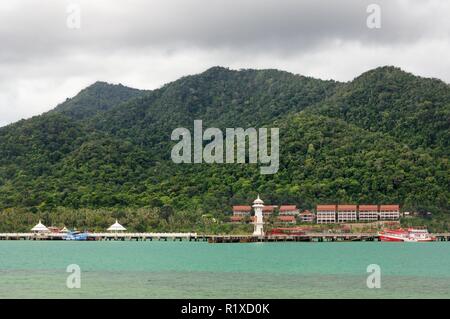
<box><xmin>0</xmin><ymin>67</ymin><xmax>450</xmax><ymax>230</ymax></box>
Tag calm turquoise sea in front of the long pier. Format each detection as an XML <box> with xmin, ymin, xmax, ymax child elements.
<box><xmin>0</xmin><ymin>241</ymin><xmax>450</xmax><ymax>298</ymax></box>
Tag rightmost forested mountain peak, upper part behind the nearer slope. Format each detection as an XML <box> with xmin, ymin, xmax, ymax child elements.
<box><xmin>313</xmin><ymin>67</ymin><xmax>450</xmax><ymax>156</ymax></box>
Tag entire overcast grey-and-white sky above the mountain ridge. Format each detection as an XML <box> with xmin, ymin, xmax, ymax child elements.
<box><xmin>0</xmin><ymin>0</ymin><xmax>450</xmax><ymax>126</ymax></box>
